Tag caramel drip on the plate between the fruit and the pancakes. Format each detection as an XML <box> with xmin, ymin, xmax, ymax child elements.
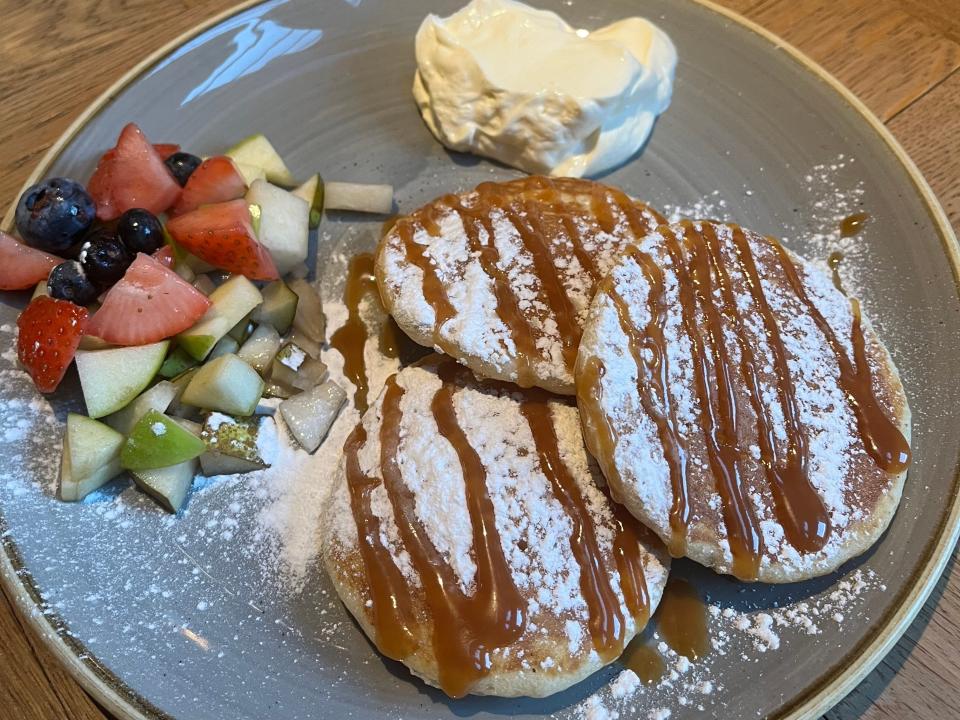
<box><xmin>330</xmin><ymin>253</ymin><xmax>380</xmax><ymax>413</ymax></box>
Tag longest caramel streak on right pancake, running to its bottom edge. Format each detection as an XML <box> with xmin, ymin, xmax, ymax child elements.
<box><xmin>664</xmin><ymin>222</ymin><xmax>763</xmax><ymax>580</ymax></box>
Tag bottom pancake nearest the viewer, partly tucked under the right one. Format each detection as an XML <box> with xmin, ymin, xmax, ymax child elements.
<box><xmin>321</xmin><ymin>355</ymin><xmax>669</xmax><ymax>697</ymax></box>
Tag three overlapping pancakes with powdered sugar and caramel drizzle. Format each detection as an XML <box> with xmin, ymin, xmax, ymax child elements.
<box><xmin>323</xmin><ymin>177</ymin><xmax>910</xmax><ymax>697</ymax></box>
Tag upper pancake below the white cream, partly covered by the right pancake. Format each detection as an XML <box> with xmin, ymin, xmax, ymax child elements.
<box><xmin>377</xmin><ymin>177</ymin><xmax>662</xmax><ymax>395</ymax></box>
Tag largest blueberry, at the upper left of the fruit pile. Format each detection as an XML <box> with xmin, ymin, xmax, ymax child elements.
<box><xmin>16</xmin><ymin>178</ymin><xmax>97</xmax><ymax>254</ymax></box>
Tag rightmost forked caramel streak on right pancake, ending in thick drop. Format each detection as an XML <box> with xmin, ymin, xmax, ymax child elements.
<box><xmin>768</xmin><ymin>243</ymin><xmax>911</xmax><ymax>473</ymax></box>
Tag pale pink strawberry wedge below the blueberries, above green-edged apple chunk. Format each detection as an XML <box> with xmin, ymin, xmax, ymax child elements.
<box><xmin>87</xmin><ymin>253</ymin><xmax>210</xmax><ymax>345</ymax></box>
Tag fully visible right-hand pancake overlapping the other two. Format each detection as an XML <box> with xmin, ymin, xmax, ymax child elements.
<box><xmin>577</xmin><ymin>221</ymin><xmax>910</xmax><ymax>582</ymax></box>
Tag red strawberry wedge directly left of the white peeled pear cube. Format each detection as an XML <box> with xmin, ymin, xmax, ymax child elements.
<box><xmin>167</xmin><ymin>200</ymin><xmax>280</xmax><ymax>280</ymax></box>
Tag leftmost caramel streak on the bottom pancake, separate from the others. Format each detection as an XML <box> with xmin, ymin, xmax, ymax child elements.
<box><xmin>343</xmin><ymin>423</ymin><xmax>417</xmax><ymax>660</ymax></box>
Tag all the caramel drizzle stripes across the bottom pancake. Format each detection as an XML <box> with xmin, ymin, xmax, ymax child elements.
<box><xmin>344</xmin><ymin>358</ymin><xmax>650</xmax><ymax>697</ymax></box>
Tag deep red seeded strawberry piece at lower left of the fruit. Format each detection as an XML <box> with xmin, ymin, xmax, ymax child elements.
<box><xmin>17</xmin><ymin>295</ymin><xmax>88</xmax><ymax>392</ymax></box>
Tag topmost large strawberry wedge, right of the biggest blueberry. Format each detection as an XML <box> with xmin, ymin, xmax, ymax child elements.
<box><xmin>87</xmin><ymin>123</ymin><xmax>180</xmax><ymax>220</ymax></box>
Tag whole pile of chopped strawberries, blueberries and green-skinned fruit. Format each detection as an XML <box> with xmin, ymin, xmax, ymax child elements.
<box><xmin>0</xmin><ymin>123</ymin><xmax>393</xmax><ymax>512</ymax></box>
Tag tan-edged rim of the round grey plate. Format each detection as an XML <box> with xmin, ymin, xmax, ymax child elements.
<box><xmin>0</xmin><ymin>0</ymin><xmax>960</xmax><ymax>720</ymax></box>
